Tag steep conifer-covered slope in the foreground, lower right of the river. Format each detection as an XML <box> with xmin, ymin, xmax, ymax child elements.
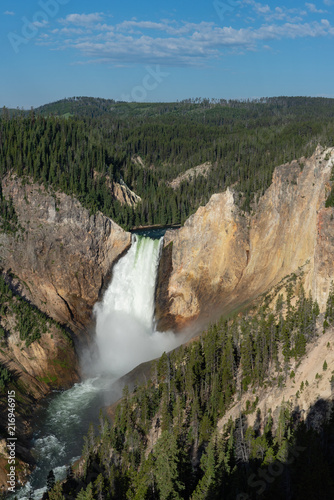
<box><xmin>45</xmin><ymin>275</ymin><xmax>334</xmax><ymax>500</ymax></box>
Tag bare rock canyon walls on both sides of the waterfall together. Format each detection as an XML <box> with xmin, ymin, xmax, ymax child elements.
<box><xmin>0</xmin><ymin>146</ymin><xmax>334</xmax><ymax>492</ymax></box>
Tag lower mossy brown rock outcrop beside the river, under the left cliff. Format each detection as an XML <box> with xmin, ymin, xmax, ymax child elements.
<box><xmin>0</xmin><ymin>325</ymin><xmax>80</xmax><ymax>493</ymax></box>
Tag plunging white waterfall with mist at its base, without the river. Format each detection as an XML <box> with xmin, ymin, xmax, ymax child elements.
<box><xmin>94</xmin><ymin>235</ymin><xmax>181</xmax><ymax>376</ymax></box>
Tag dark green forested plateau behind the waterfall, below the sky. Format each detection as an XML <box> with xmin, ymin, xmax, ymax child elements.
<box><xmin>0</xmin><ymin>97</ymin><xmax>334</xmax><ymax>229</ymax></box>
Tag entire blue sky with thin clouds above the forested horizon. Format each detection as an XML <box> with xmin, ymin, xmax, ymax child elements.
<box><xmin>0</xmin><ymin>0</ymin><xmax>334</xmax><ymax>109</ymax></box>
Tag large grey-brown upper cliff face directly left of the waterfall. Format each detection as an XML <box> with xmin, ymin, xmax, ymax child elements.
<box><xmin>0</xmin><ymin>176</ymin><xmax>131</xmax><ymax>332</ymax></box>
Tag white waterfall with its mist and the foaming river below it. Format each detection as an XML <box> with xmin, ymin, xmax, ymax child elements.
<box><xmin>10</xmin><ymin>235</ymin><xmax>186</xmax><ymax>500</ymax></box>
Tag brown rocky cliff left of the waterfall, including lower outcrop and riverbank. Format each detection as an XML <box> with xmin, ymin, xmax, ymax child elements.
<box><xmin>0</xmin><ymin>176</ymin><xmax>131</xmax><ymax>491</ymax></box>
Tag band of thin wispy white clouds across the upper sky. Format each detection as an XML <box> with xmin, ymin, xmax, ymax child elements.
<box><xmin>37</xmin><ymin>9</ymin><xmax>334</xmax><ymax>66</ymax></box>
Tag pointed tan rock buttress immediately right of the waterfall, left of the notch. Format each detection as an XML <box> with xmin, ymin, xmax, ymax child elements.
<box><xmin>156</xmin><ymin>189</ymin><xmax>249</xmax><ymax>330</ymax></box>
